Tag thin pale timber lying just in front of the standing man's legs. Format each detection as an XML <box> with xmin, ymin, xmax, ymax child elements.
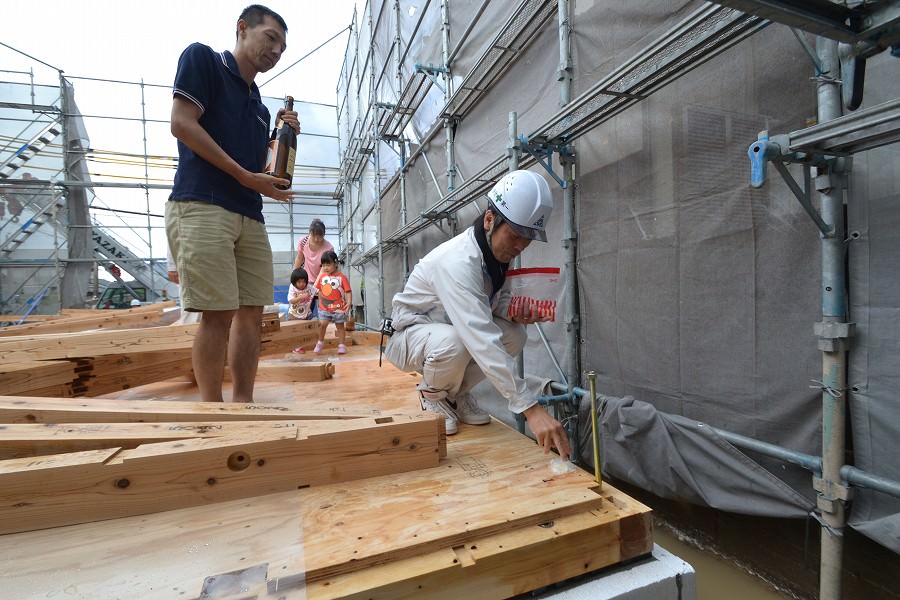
<box><xmin>0</xmin><ymin>396</ymin><xmax>381</xmax><ymax>423</ymax></box>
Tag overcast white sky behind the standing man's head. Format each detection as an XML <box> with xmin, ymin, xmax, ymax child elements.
<box><xmin>0</xmin><ymin>0</ymin><xmax>365</xmax><ymax>104</ymax></box>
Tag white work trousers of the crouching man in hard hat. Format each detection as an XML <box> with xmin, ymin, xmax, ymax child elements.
<box><xmin>384</xmin><ymin>317</ymin><xmax>528</xmax><ymax>399</ymax></box>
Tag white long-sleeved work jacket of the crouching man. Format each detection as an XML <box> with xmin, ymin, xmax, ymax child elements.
<box><xmin>392</xmin><ymin>227</ymin><xmax>537</xmax><ymax>413</ymax></box>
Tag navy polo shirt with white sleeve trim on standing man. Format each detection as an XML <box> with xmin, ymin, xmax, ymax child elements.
<box><xmin>169</xmin><ymin>44</ymin><xmax>269</xmax><ymax>222</ymax></box>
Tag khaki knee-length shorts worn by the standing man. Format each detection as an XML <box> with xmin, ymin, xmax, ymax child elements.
<box><xmin>166</xmin><ymin>200</ymin><xmax>274</xmax><ymax>311</ymax></box>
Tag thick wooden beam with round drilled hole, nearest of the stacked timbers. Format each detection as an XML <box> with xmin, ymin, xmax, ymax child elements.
<box><xmin>0</xmin><ymin>413</ymin><xmax>446</xmax><ymax>534</ymax></box>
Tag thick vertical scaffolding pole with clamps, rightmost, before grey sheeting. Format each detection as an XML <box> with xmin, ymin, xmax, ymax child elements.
<box><xmin>814</xmin><ymin>37</ymin><xmax>848</xmax><ymax>600</ymax></box>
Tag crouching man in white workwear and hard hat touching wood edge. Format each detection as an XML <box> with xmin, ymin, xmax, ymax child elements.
<box><xmin>384</xmin><ymin>171</ymin><xmax>570</xmax><ymax>458</ymax></box>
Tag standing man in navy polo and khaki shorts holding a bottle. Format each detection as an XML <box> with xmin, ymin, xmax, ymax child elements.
<box><xmin>166</xmin><ymin>4</ymin><xmax>300</xmax><ymax>402</ymax></box>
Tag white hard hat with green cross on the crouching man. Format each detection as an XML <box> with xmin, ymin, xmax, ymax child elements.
<box><xmin>488</xmin><ymin>171</ymin><xmax>553</xmax><ymax>242</ymax></box>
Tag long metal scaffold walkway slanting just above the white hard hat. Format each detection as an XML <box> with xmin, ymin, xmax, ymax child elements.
<box><xmin>353</xmin><ymin>4</ymin><xmax>769</xmax><ymax>266</ymax></box>
